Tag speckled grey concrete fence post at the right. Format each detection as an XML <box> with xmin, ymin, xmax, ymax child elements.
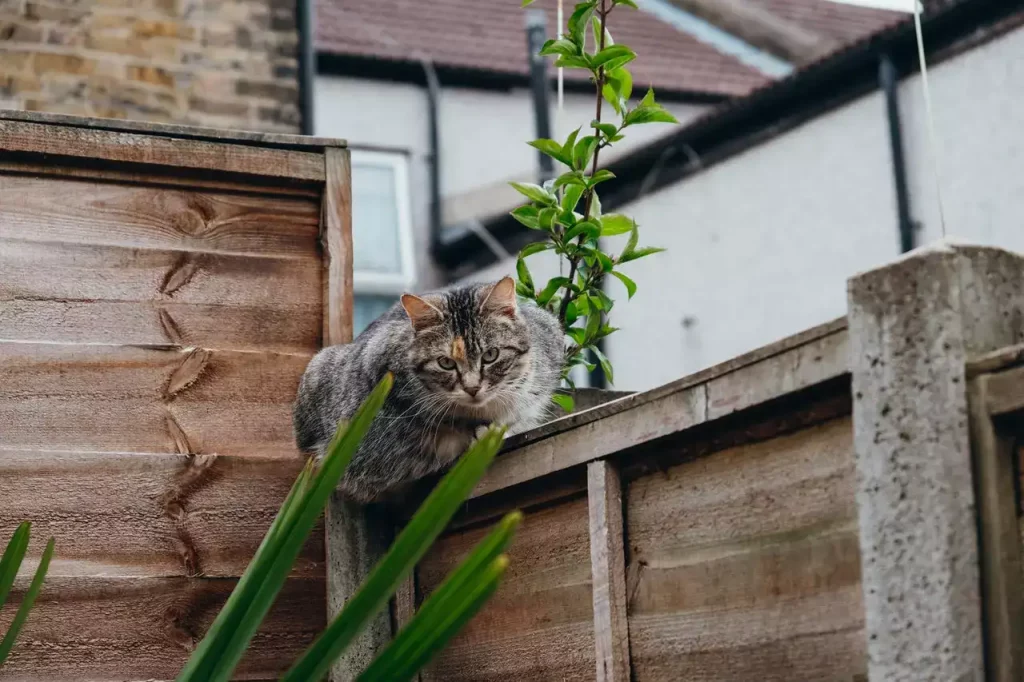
<box><xmin>849</xmin><ymin>242</ymin><xmax>1024</xmax><ymax>682</ymax></box>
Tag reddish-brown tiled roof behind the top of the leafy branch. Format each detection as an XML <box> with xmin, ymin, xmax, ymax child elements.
<box><xmin>316</xmin><ymin>0</ymin><xmax>770</xmax><ymax>96</ymax></box>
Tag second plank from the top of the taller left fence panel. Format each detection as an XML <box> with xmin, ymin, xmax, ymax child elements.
<box><xmin>0</xmin><ymin>241</ymin><xmax>323</xmax><ymax>353</ymax></box>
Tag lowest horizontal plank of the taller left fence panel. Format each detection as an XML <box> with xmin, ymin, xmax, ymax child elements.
<box><xmin>0</xmin><ymin>569</ymin><xmax>326</xmax><ymax>682</ymax></box>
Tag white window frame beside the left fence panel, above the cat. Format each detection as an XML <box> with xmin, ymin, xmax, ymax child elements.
<box><xmin>350</xmin><ymin>150</ymin><xmax>416</xmax><ymax>296</ymax></box>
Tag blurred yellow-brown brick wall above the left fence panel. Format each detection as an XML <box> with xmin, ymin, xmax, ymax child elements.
<box><xmin>0</xmin><ymin>0</ymin><xmax>300</xmax><ymax>132</ymax></box>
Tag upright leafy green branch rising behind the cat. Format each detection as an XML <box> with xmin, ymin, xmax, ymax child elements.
<box><xmin>512</xmin><ymin>0</ymin><xmax>678</xmax><ymax>410</ymax></box>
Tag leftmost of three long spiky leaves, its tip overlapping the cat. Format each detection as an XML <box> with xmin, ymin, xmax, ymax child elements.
<box><xmin>177</xmin><ymin>373</ymin><xmax>394</xmax><ymax>682</ymax></box>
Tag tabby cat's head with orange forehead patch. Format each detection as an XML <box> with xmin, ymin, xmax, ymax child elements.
<box><xmin>401</xmin><ymin>278</ymin><xmax>529</xmax><ymax>409</ymax></box>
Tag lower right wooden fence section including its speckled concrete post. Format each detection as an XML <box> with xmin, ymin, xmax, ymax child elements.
<box><xmin>350</xmin><ymin>244</ymin><xmax>1024</xmax><ymax>682</ymax></box>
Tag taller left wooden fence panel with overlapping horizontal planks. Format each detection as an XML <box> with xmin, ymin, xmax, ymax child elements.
<box><xmin>0</xmin><ymin>112</ymin><xmax>351</xmax><ymax>681</ymax></box>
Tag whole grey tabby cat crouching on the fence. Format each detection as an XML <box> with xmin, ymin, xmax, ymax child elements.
<box><xmin>293</xmin><ymin>278</ymin><xmax>564</xmax><ymax>504</ymax></box>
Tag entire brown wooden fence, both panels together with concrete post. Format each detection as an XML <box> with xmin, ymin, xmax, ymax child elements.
<box><xmin>0</xmin><ymin>113</ymin><xmax>1024</xmax><ymax>682</ymax></box>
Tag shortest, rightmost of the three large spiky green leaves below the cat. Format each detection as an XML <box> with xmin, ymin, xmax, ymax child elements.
<box><xmin>357</xmin><ymin>512</ymin><xmax>522</xmax><ymax>682</ymax></box>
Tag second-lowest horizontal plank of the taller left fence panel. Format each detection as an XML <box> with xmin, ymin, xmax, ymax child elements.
<box><xmin>0</xmin><ymin>450</ymin><xmax>325</xmax><ymax>578</ymax></box>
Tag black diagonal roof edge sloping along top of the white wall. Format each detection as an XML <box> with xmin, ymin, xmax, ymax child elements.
<box><xmin>437</xmin><ymin>0</ymin><xmax>1024</xmax><ymax>268</ymax></box>
